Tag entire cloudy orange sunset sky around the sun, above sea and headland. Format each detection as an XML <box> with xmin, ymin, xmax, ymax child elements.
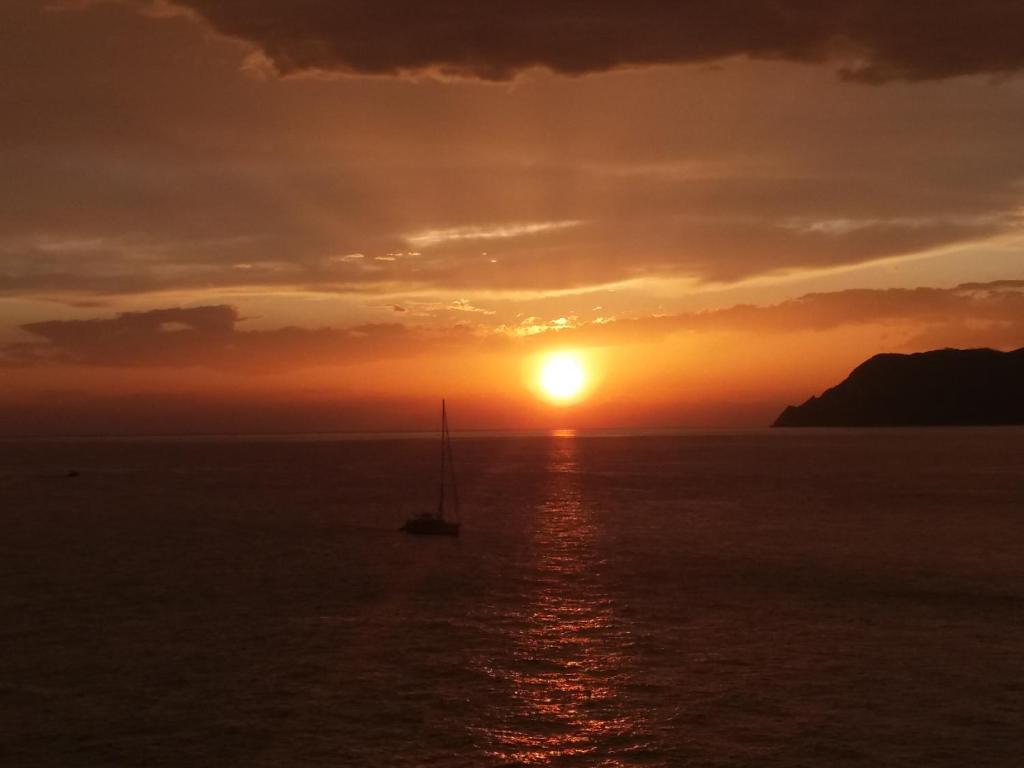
<box><xmin>0</xmin><ymin>0</ymin><xmax>1024</xmax><ymax>434</ymax></box>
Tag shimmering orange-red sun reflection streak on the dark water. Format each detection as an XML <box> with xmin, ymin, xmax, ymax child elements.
<box><xmin>482</xmin><ymin>435</ymin><xmax>638</xmax><ymax>766</ymax></box>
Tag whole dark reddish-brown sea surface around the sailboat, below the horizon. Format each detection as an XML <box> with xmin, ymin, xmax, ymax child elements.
<box><xmin>0</xmin><ymin>429</ymin><xmax>1024</xmax><ymax>768</ymax></box>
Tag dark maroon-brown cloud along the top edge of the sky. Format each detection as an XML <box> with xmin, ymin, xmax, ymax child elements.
<box><xmin>163</xmin><ymin>0</ymin><xmax>1024</xmax><ymax>82</ymax></box>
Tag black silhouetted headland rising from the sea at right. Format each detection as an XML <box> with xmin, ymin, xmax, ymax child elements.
<box><xmin>772</xmin><ymin>348</ymin><xmax>1024</xmax><ymax>427</ymax></box>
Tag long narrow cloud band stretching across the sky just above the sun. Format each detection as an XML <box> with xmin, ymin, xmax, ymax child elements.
<box><xmin>0</xmin><ymin>281</ymin><xmax>1024</xmax><ymax>373</ymax></box>
